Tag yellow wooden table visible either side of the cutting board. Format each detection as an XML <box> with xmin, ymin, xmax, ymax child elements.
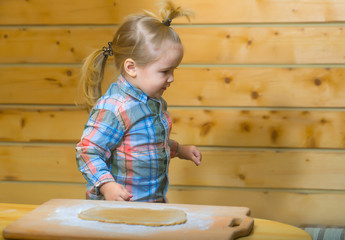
<box><xmin>0</xmin><ymin>203</ymin><xmax>312</xmax><ymax>240</ymax></box>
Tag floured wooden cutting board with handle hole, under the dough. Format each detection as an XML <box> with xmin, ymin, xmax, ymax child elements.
<box><xmin>3</xmin><ymin>199</ymin><xmax>254</xmax><ymax>240</ymax></box>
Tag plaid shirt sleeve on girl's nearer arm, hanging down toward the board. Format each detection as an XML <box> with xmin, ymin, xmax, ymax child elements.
<box><xmin>76</xmin><ymin>109</ymin><xmax>124</xmax><ymax>198</ymax></box>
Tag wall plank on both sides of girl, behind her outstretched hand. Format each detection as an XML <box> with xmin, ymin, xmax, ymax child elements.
<box><xmin>0</xmin><ymin>144</ymin><xmax>345</xmax><ymax>190</ymax></box>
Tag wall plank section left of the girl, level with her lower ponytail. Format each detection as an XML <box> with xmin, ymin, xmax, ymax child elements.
<box><xmin>0</xmin><ymin>64</ymin><xmax>119</xmax><ymax>105</ymax></box>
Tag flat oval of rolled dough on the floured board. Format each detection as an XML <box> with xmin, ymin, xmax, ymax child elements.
<box><xmin>79</xmin><ymin>207</ymin><xmax>187</xmax><ymax>226</ymax></box>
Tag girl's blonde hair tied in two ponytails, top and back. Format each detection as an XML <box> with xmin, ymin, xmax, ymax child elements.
<box><xmin>80</xmin><ymin>1</ymin><xmax>193</xmax><ymax>110</ymax></box>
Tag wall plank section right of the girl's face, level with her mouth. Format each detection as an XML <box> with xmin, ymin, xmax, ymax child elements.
<box><xmin>171</xmin><ymin>67</ymin><xmax>345</xmax><ymax>107</ymax></box>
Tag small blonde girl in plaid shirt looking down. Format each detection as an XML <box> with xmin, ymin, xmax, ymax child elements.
<box><xmin>76</xmin><ymin>2</ymin><xmax>201</xmax><ymax>202</ymax></box>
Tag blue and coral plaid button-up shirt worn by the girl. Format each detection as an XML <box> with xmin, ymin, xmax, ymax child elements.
<box><xmin>76</xmin><ymin>76</ymin><xmax>178</xmax><ymax>202</ymax></box>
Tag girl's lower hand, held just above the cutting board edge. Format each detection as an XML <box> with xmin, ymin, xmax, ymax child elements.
<box><xmin>99</xmin><ymin>182</ymin><xmax>133</xmax><ymax>201</ymax></box>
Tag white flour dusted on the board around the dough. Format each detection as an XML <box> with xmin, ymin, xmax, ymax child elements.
<box><xmin>45</xmin><ymin>201</ymin><xmax>213</xmax><ymax>235</ymax></box>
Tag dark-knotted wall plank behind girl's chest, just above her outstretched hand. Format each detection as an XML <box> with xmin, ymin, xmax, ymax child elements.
<box><xmin>0</xmin><ymin>108</ymin><xmax>345</xmax><ymax>148</ymax></box>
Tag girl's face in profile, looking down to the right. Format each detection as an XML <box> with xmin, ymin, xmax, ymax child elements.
<box><xmin>136</xmin><ymin>41</ymin><xmax>183</xmax><ymax>99</ymax></box>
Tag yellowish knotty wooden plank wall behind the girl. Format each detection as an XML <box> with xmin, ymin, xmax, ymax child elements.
<box><xmin>0</xmin><ymin>0</ymin><xmax>345</xmax><ymax>225</ymax></box>
